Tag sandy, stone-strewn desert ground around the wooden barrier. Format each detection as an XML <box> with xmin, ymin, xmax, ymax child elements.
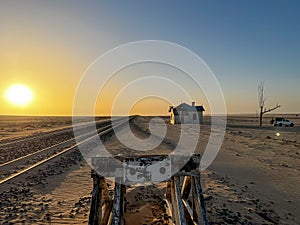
<box><xmin>0</xmin><ymin>116</ymin><xmax>300</xmax><ymax>225</ymax></box>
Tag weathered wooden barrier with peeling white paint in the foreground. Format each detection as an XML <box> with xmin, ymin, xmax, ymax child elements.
<box><xmin>89</xmin><ymin>154</ymin><xmax>208</xmax><ymax>225</ymax></box>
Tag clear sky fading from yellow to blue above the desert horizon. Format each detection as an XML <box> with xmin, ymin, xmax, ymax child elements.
<box><xmin>0</xmin><ymin>0</ymin><xmax>300</xmax><ymax>115</ymax></box>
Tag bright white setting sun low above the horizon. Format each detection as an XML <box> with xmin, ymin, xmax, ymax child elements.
<box><xmin>6</xmin><ymin>84</ymin><xmax>33</xmax><ymax>106</ymax></box>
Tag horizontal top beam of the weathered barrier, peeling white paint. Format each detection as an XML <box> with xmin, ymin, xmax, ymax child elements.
<box><xmin>92</xmin><ymin>154</ymin><xmax>201</xmax><ymax>179</ymax></box>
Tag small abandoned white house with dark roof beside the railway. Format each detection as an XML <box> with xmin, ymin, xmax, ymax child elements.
<box><xmin>169</xmin><ymin>102</ymin><xmax>205</xmax><ymax>124</ymax></box>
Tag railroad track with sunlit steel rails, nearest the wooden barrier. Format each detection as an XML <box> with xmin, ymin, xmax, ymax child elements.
<box><xmin>0</xmin><ymin>117</ymin><xmax>134</xmax><ymax>185</ymax></box>
